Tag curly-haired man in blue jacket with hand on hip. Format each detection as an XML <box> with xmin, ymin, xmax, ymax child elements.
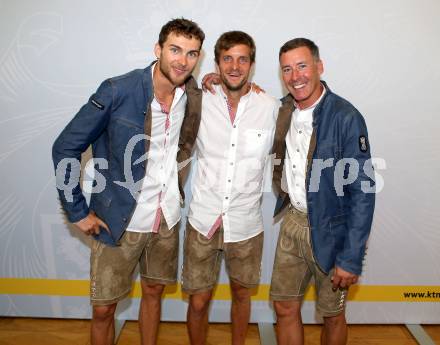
<box><xmin>53</xmin><ymin>18</ymin><xmax>205</xmax><ymax>344</ymax></box>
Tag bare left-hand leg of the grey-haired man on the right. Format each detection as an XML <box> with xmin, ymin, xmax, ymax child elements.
<box><xmin>273</xmin><ymin>300</ymin><xmax>304</xmax><ymax>345</ymax></box>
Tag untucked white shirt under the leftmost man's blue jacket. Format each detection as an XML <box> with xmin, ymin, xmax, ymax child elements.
<box><xmin>127</xmin><ymin>65</ymin><xmax>186</xmax><ymax>232</ymax></box>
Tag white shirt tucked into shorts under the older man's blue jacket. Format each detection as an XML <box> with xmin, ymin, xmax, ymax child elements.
<box><xmin>284</xmin><ymin>88</ymin><xmax>325</xmax><ymax>212</ymax></box>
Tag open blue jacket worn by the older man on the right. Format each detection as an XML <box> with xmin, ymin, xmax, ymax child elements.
<box><xmin>272</xmin><ymin>82</ymin><xmax>375</xmax><ymax>275</ymax></box>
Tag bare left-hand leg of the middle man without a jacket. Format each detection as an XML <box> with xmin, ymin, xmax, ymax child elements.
<box><xmin>186</xmin><ymin>290</ymin><xmax>212</xmax><ymax>345</ymax></box>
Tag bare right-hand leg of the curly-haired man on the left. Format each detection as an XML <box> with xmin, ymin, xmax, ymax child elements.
<box><xmin>139</xmin><ymin>278</ymin><xmax>165</xmax><ymax>345</ymax></box>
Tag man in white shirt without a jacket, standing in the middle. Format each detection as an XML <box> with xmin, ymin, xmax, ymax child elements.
<box><xmin>182</xmin><ymin>31</ymin><xmax>279</xmax><ymax>345</ymax></box>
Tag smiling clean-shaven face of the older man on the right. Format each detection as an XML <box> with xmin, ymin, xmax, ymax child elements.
<box><xmin>280</xmin><ymin>47</ymin><xmax>324</xmax><ymax>109</ymax></box>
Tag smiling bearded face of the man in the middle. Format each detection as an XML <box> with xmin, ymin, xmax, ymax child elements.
<box><xmin>217</xmin><ymin>44</ymin><xmax>252</xmax><ymax>91</ymax></box>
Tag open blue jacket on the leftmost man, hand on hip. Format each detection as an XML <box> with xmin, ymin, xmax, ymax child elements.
<box><xmin>52</xmin><ymin>66</ymin><xmax>201</xmax><ymax>245</ymax></box>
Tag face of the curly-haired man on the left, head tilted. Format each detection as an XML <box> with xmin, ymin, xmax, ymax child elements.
<box><xmin>154</xmin><ymin>32</ymin><xmax>201</xmax><ymax>86</ymax></box>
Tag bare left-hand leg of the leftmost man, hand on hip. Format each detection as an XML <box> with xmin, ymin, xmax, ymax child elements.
<box><xmin>90</xmin><ymin>303</ymin><xmax>116</xmax><ymax>345</ymax></box>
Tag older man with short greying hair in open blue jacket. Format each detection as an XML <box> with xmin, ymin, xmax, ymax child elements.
<box><xmin>270</xmin><ymin>38</ymin><xmax>375</xmax><ymax>345</ymax></box>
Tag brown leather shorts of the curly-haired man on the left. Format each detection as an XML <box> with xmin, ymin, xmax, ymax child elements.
<box><xmin>90</xmin><ymin>219</ymin><xmax>179</xmax><ymax>305</ymax></box>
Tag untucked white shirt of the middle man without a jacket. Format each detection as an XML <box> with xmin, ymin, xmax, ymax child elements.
<box><xmin>188</xmin><ymin>86</ymin><xmax>279</xmax><ymax>242</ymax></box>
